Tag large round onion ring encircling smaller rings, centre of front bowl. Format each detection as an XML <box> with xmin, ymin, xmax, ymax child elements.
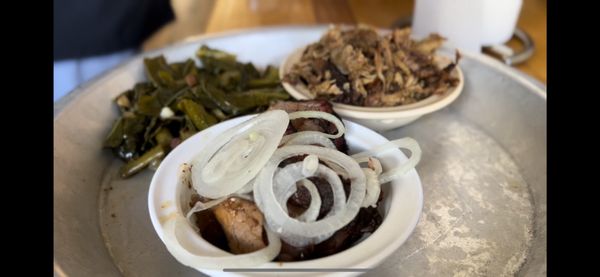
<box><xmin>254</xmin><ymin>145</ymin><xmax>366</xmax><ymax>246</ymax></box>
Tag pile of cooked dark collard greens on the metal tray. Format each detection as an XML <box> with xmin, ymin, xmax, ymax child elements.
<box><xmin>104</xmin><ymin>45</ymin><xmax>289</xmax><ymax>178</ymax></box>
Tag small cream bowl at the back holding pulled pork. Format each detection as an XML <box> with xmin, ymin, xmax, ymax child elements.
<box><xmin>279</xmin><ymin>46</ymin><xmax>464</xmax><ymax>131</ymax></box>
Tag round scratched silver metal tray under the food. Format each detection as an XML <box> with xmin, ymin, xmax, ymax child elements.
<box><xmin>54</xmin><ymin>27</ymin><xmax>546</xmax><ymax>276</ymax></box>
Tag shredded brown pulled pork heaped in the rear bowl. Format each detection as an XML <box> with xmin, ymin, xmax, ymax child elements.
<box><xmin>283</xmin><ymin>26</ymin><xmax>460</xmax><ymax>107</ymax></box>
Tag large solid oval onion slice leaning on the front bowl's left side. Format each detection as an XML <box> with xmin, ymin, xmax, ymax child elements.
<box><xmin>192</xmin><ymin>110</ymin><xmax>289</xmax><ymax>199</ymax></box>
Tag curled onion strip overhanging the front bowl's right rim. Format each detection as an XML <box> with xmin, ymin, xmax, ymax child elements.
<box><xmin>352</xmin><ymin>138</ymin><xmax>421</xmax><ymax>184</ymax></box>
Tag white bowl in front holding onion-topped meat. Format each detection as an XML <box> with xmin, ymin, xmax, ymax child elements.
<box><xmin>148</xmin><ymin>115</ymin><xmax>423</xmax><ymax>276</ymax></box>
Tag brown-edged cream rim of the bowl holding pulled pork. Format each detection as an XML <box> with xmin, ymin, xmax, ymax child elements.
<box><xmin>279</xmin><ymin>45</ymin><xmax>465</xmax><ymax>119</ymax></box>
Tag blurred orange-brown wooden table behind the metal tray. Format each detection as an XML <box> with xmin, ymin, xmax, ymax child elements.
<box><xmin>143</xmin><ymin>0</ymin><xmax>546</xmax><ymax>83</ymax></box>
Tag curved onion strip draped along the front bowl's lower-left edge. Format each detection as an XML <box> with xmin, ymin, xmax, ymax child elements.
<box><xmin>163</xmin><ymin>215</ymin><xmax>281</xmax><ymax>270</ymax></box>
